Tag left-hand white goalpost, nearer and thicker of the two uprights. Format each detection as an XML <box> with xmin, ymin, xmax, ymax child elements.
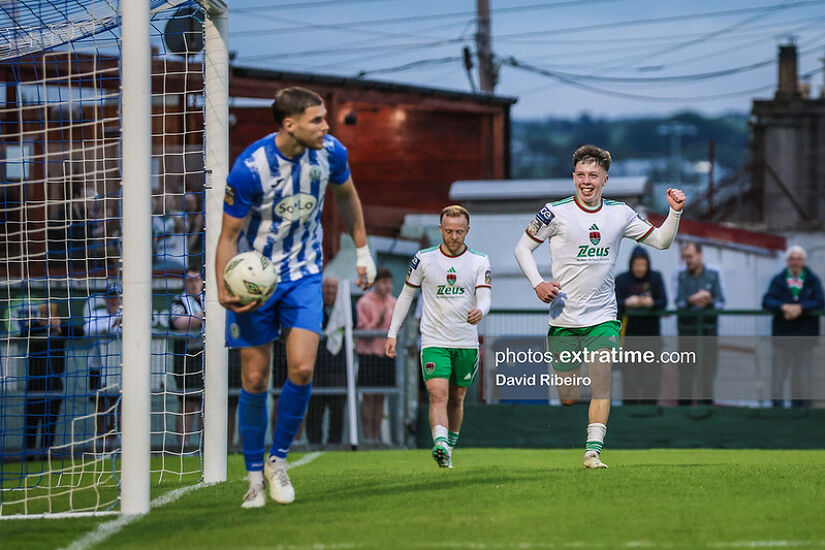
<box><xmin>120</xmin><ymin>0</ymin><xmax>152</xmax><ymax>515</ymax></box>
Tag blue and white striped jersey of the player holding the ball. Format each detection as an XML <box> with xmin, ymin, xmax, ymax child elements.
<box><xmin>223</xmin><ymin>133</ymin><xmax>350</xmax><ymax>281</ymax></box>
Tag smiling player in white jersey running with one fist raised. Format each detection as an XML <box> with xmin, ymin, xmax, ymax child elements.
<box><xmin>515</xmin><ymin>145</ymin><xmax>685</xmax><ymax>468</ymax></box>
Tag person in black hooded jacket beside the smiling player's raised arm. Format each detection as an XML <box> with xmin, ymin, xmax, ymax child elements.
<box><xmin>616</xmin><ymin>246</ymin><xmax>667</xmax><ymax>405</ymax></box>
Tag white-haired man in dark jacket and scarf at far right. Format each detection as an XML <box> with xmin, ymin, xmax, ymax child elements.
<box><xmin>762</xmin><ymin>246</ymin><xmax>825</xmax><ymax>407</ymax></box>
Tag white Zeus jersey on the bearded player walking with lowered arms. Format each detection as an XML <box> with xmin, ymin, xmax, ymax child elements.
<box><xmin>406</xmin><ymin>246</ymin><xmax>491</xmax><ymax>348</ymax></box>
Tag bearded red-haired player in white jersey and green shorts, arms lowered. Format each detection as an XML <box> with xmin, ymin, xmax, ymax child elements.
<box><xmin>385</xmin><ymin>206</ymin><xmax>490</xmax><ymax>468</ymax></box>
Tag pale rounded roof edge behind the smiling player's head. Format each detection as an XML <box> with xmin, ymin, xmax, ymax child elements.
<box><xmin>450</xmin><ymin>177</ymin><xmax>650</xmax><ymax>201</ymax></box>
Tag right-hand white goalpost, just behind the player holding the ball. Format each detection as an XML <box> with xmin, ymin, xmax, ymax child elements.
<box><xmin>203</xmin><ymin>0</ymin><xmax>229</xmax><ymax>483</ymax></box>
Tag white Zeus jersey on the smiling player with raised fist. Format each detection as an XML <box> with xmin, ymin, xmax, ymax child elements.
<box><xmin>527</xmin><ymin>196</ymin><xmax>654</xmax><ymax>327</ymax></box>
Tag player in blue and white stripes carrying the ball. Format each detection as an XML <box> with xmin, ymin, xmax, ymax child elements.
<box><xmin>215</xmin><ymin>88</ymin><xmax>375</xmax><ymax>508</ymax></box>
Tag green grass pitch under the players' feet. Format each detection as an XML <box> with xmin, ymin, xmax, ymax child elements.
<box><xmin>0</xmin><ymin>448</ymin><xmax>825</xmax><ymax>550</ymax></box>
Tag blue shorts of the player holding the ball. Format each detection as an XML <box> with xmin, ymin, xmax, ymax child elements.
<box><xmin>226</xmin><ymin>273</ymin><xmax>324</xmax><ymax>348</ymax></box>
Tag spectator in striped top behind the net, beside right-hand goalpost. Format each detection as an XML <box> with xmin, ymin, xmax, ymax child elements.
<box><xmin>170</xmin><ymin>269</ymin><xmax>204</xmax><ymax>452</ymax></box>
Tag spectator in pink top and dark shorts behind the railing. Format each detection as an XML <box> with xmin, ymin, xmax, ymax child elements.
<box><xmin>355</xmin><ymin>269</ymin><xmax>395</xmax><ymax>443</ymax></box>
